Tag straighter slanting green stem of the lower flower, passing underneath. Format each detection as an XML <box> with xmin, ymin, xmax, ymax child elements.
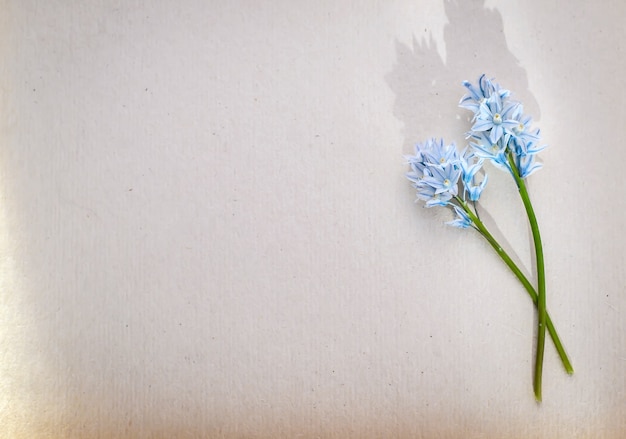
<box><xmin>456</xmin><ymin>197</ymin><xmax>574</xmax><ymax>375</ymax></box>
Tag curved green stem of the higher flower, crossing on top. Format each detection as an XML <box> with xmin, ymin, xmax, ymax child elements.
<box><xmin>508</xmin><ymin>151</ymin><xmax>547</xmax><ymax>401</ymax></box>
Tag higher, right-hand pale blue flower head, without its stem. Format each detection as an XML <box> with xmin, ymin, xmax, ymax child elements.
<box><xmin>459</xmin><ymin>75</ymin><xmax>545</xmax><ymax>178</ymax></box>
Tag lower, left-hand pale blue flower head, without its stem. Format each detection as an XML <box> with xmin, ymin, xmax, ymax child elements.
<box><xmin>406</xmin><ymin>139</ymin><xmax>487</xmax><ymax>228</ymax></box>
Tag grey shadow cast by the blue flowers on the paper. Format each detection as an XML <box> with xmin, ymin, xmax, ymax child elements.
<box><xmin>385</xmin><ymin>0</ymin><xmax>540</xmax><ymax>277</ymax></box>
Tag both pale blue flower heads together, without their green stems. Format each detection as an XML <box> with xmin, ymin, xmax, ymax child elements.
<box><xmin>406</xmin><ymin>75</ymin><xmax>544</xmax><ymax>228</ymax></box>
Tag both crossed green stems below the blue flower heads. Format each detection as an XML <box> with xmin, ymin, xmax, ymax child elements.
<box><xmin>455</xmin><ymin>198</ymin><xmax>574</xmax><ymax>401</ymax></box>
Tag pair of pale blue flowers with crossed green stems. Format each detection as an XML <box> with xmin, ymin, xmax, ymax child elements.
<box><xmin>406</xmin><ymin>74</ymin><xmax>573</xmax><ymax>401</ymax></box>
